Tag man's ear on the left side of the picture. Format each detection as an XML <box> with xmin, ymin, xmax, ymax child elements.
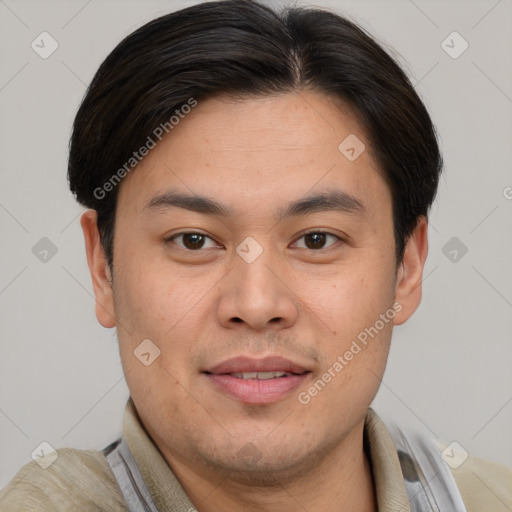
<box><xmin>80</xmin><ymin>210</ymin><xmax>116</xmax><ymax>327</ymax></box>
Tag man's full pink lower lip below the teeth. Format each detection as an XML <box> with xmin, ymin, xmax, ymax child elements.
<box><xmin>206</xmin><ymin>373</ymin><xmax>309</xmax><ymax>404</ymax></box>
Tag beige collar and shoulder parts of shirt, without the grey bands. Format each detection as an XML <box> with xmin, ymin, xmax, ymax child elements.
<box><xmin>0</xmin><ymin>398</ymin><xmax>512</xmax><ymax>512</ymax></box>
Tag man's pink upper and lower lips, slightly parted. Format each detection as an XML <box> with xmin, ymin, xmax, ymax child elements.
<box><xmin>203</xmin><ymin>356</ymin><xmax>311</xmax><ymax>404</ymax></box>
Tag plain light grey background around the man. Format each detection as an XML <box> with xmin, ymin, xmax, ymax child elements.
<box><xmin>0</xmin><ymin>0</ymin><xmax>512</xmax><ymax>486</ymax></box>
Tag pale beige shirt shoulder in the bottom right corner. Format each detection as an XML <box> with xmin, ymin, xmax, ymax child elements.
<box><xmin>452</xmin><ymin>457</ymin><xmax>512</xmax><ymax>512</ymax></box>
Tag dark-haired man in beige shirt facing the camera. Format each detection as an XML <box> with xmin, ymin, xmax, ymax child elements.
<box><xmin>0</xmin><ymin>0</ymin><xmax>512</xmax><ymax>512</ymax></box>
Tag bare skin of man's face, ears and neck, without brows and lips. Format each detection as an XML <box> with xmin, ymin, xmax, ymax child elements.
<box><xmin>81</xmin><ymin>91</ymin><xmax>428</xmax><ymax>512</ymax></box>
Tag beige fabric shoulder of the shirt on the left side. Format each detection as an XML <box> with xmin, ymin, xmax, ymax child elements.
<box><xmin>0</xmin><ymin>448</ymin><xmax>128</xmax><ymax>512</ymax></box>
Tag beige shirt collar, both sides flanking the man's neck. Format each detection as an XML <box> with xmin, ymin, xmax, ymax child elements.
<box><xmin>123</xmin><ymin>397</ymin><xmax>410</xmax><ymax>512</ymax></box>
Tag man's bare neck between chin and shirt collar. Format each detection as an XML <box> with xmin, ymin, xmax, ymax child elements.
<box><xmin>164</xmin><ymin>424</ymin><xmax>377</xmax><ymax>512</ymax></box>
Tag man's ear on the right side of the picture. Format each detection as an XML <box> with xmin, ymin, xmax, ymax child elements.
<box><xmin>394</xmin><ymin>216</ymin><xmax>428</xmax><ymax>325</ymax></box>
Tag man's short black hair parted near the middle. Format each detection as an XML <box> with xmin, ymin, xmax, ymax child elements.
<box><xmin>68</xmin><ymin>0</ymin><xmax>442</xmax><ymax>267</ymax></box>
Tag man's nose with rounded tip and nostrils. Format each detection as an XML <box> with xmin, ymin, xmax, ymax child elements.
<box><xmin>217</xmin><ymin>244</ymin><xmax>299</xmax><ymax>331</ymax></box>
